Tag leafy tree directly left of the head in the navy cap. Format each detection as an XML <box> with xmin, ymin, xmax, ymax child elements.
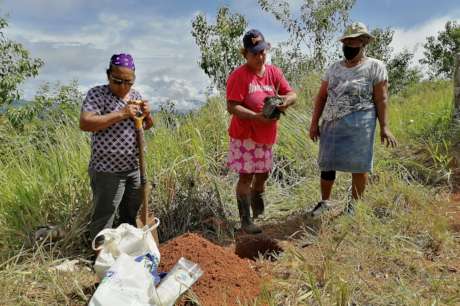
<box><xmin>192</xmin><ymin>7</ymin><xmax>248</xmax><ymax>91</ymax></box>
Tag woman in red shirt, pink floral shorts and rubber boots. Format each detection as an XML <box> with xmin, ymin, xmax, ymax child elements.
<box><xmin>227</xmin><ymin>30</ymin><xmax>297</xmax><ymax>234</ymax></box>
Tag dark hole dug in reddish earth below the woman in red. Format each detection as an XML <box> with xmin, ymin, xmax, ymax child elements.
<box><xmin>235</xmin><ymin>234</ymin><xmax>283</xmax><ymax>260</ymax></box>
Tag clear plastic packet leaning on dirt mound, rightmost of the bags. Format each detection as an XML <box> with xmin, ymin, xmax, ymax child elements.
<box><xmin>151</xmin><ymin>257</ymin><xmax>203</xmax><ymax>306</ymax></box>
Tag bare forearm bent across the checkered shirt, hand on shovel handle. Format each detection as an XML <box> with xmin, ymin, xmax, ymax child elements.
<box><xmin>80</xmin><ymin>105</ymin><xmax>138</xmax><ymax>132</ymax></box>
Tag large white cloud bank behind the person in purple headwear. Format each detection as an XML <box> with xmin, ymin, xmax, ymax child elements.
<box><xmin>7</xmin><ymin>12</ymin><xmax>209</xmax><ymax>110</ymax></box>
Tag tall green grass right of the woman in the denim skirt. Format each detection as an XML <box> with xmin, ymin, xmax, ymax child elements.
<box><xmin>376</xmin><ymin>81</ymin><xmax>455</xmax><ymax>184</ymax></box>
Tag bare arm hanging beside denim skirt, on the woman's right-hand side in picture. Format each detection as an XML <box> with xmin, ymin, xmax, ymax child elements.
<box><xmin>373</xmin><ymin>81</ymin><xmax>398</xmax><ymax>147</ymax></box>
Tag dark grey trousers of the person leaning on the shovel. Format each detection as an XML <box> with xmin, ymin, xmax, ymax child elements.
<box><xmin>89</xmin><ymin>169</ymin><xmax>141</xmax><ymax>239</ymax></box>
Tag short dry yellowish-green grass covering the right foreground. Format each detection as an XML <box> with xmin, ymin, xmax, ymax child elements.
<box><xmin>260</xmin><ymin>173</ymin><xmax>460</xmax><ymax>305</ymax></box>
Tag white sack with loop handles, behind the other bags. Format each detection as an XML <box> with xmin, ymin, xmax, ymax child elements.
<box><xmin>92</xmin><ymin>218</ymin><xmax>160</xmax><ymax>279</ymax></box>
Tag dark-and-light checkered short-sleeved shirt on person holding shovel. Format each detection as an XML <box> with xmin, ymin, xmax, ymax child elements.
<box><xmin>81</xmin><ymin>85</ymin><xmax>142</xmax><ymax>172</ymax></box>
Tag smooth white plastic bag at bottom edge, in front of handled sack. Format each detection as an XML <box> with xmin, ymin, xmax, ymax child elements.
<box><xmin>88</xmin><ymin>253</ymin><xmax>155</xmax><ymax>306</ymax></box>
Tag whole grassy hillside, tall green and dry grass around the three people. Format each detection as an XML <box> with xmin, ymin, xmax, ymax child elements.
<box><xmin>0</xmin><ymin>77</ymin><xmax>460</xmax><ymax>305</ymax></box>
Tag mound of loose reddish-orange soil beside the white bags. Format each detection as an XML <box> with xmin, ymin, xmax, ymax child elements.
<box><xmin>160</xmin><ymin>234</ymin><xmax>260</xmax><ymax>306</ymax></box>
